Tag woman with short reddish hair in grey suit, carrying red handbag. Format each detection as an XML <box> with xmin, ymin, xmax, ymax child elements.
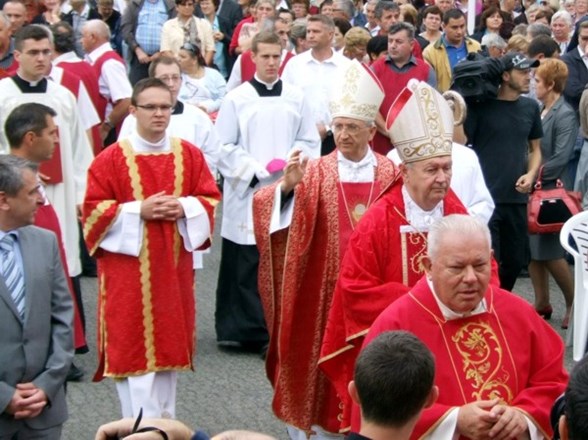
<box><xmin>529</xmin><ymin>58</ymin><xmax>578</xmax><ymax>328</ymax></box>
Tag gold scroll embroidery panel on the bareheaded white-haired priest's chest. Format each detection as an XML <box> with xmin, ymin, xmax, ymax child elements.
<box><xmin>451</xmin><ymin>322</ymin><xmax>514</xmax><ymax>403</ymax></box>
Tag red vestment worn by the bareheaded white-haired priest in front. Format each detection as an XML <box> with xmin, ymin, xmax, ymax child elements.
<box><xmin>352</xmin><ymin>277</ymin><xmax>568</xmax><ymax>439</ymax></box>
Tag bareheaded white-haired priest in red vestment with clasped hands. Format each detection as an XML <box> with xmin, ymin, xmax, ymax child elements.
<box><xmin>354</xmin><ymin>215</ymin><xmax>568</xmax><ymax>440</ymax></box>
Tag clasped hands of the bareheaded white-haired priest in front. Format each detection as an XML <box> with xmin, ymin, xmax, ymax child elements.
<box><xmin>457</xmin><ymin>399</ymin><xmax>530</xmax><ymax>440</ymax></box>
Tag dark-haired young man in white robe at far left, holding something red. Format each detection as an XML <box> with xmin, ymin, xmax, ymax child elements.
<box><xmin>0</xmin><ymin>25</ymin><xmax>93</xmax><ymax>277</ymax></box>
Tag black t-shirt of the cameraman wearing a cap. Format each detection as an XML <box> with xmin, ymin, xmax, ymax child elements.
<box><xmin>464</xmin><ymin>96</ymin><xmax>543</xmax><ymax>203</ymax></box>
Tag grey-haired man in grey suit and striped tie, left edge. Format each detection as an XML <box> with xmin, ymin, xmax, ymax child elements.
<box><xmin>0</xmin><ymin>155</ymin><xmax>74</xmax><ymax>440</ymax></box>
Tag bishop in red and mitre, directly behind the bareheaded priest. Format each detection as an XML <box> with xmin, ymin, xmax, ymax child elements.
<box><xmin>320</xmin><ymin>80</ymin><xmax>490</xmax><ymax>432</ymax></box>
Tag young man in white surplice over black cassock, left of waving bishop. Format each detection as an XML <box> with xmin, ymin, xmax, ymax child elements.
<box><xmin>216</xmin><ymin>31</ymin><xmax>320</xmax><ymax>350</ymax></box>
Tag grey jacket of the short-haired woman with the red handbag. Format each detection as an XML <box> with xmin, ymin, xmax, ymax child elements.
<box><xmin>541</xmin><ymin>96</ymin><xmax>578</xmax><ymax>189</ymax></box>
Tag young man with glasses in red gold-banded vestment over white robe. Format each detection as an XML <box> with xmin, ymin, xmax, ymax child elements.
<box><xmin>83</xmin><ymin>78</ymin><xmax>220</xmax><ymax>417</ymax></box>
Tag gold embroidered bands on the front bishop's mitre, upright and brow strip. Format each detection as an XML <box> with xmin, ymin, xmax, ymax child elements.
<box><xmin>395</xmin><ymin>87</ymin><xmax>453</xmax><ymax>162</ymax></box>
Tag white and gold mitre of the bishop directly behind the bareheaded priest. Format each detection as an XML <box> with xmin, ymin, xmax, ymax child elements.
<box><xmin>386</xmin><ymin>79</ymin><xmax>453</xmax><ymax>163</ymax></box>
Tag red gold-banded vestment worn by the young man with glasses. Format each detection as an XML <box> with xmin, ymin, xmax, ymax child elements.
<box><xmin>84</xmin><ymin>139</ymin><xmax>220</xmax><ymax>380</ymax></box>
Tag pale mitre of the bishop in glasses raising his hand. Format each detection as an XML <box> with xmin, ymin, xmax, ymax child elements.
<box><xmin>329</xmin><ymin>60</ymin><xmax>384</xmax><ymax>122</ymax></box>
